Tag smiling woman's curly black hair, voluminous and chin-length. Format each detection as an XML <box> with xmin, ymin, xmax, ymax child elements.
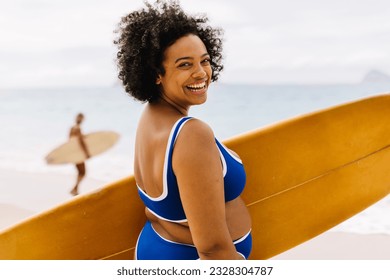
<box><xmin>114</xmin><ymin>0</ymin><xmax>223</xmax><ymax>103</ymax></box>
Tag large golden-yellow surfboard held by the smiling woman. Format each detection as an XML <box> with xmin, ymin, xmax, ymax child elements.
<box><xmin>0</xmin><ymin>95</ymin><xmax>390</xmax><ymax>259</ymax></box>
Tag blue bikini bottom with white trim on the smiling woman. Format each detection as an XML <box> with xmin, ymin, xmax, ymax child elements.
<box><xmin>135</xmin><ymin>221</ymin><xmax>252</xmax><ymax>260</ymax></box>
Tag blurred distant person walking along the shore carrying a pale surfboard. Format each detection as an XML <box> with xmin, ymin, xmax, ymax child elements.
<box><xmin>69</xmin><ymin>113</ymin><xmax>90</xmax><ymax>195</ymax></box>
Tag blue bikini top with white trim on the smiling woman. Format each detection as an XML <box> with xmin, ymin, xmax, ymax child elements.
<box><xmin>138</xmin><ymin>117</ymin><xmax>246</xmax><ymax>223</ymax></box>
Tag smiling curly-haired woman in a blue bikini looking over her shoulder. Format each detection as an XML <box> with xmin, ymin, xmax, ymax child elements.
<box><xmin>115</xmin><ymin>1</ymin><xmax>252</xmax><ymax>260</ymax></box>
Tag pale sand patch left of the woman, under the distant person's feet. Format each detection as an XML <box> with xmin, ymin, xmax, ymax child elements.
<box><xmin>0</xmin><ymin>169</ymin><xmax>107</xmax><ymax>230</ymax></box>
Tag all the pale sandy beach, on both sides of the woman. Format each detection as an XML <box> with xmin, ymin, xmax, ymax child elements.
<box><xmin>0</xmin><ymin>166</ymin><xmax>390</xmax><ymax>260</ymax></box>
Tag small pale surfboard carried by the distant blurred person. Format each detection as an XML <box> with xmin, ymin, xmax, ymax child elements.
<box><xmin>45</xmin><ymin>131</ymin><xmax>119</xmax><ymax>164</ymax></box>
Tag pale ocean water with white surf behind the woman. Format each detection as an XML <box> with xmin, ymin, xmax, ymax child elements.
<box><xmin>0</xmin><ymin>83</ymin><xmax>390</xmax><ymax>234</ymax></box>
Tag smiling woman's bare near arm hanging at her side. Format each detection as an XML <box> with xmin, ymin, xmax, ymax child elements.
<box><xmin>173</xmin><ymin>119</ymin><xmax>242</xmax><ymax>259</ymax></box>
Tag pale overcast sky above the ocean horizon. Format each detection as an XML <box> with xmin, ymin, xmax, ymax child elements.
<box><xmin>0</xmin><ymin>0</ymin><xmax>390</xmax><ymax>88</ymax></box>
